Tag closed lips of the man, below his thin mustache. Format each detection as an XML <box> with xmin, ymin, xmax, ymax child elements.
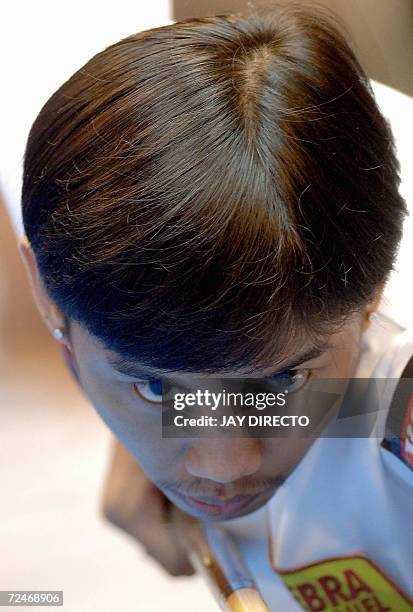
<box><xmin>175</xmin><ymin>490</ymin><xmax>273</xmax><ymax>519</ymax></box>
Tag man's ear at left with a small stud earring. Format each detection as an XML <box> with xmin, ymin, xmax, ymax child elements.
<box><xmin>18</xmin><ymin>236</ymin><xmax>70</xmax><ymax>348</ymax></box>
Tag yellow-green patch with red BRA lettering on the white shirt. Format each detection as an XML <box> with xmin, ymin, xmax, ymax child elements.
<box><xmin>277</xmin><ymin>556</ymin><xmax>413</xmax><ymax>612</ymax></box>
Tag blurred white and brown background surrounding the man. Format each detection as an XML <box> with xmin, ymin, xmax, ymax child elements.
<box><xmin>0</xmin><ymin>0</ymin><xmax>413</xmax><ymax>612</ymax></box>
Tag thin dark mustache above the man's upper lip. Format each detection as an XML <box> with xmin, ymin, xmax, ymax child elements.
<box><xmin>157</xmin><ymin>474</ymin><xmax>286</xmax><ymax>498</ymax></box>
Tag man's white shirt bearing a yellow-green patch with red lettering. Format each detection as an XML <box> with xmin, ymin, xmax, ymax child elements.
<box><xmin>225</xmin><ymin>308</ymin><xmax>413</xmax><ymax>612</ymax></box>
